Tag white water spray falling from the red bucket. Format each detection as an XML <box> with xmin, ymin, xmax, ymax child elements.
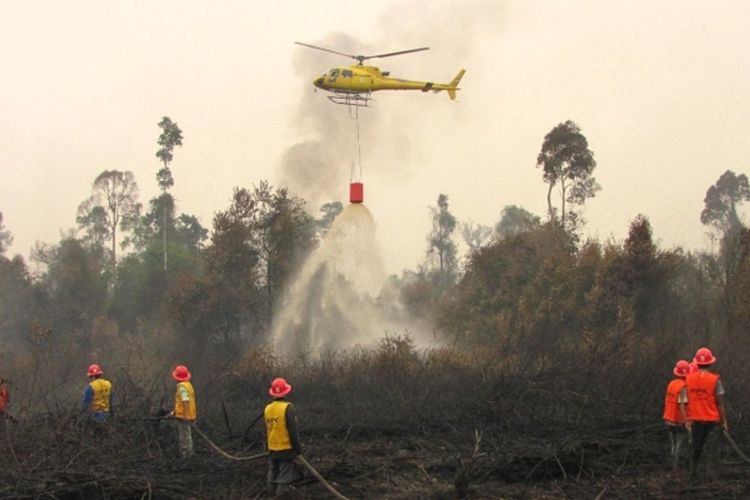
<box><xmin>273</xmin><ymin>199</ymin><xmax>395</xmax><ymax>355</ymax></box>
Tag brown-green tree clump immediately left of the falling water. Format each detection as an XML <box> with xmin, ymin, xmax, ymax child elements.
<box><xmin>170</xmin><ymin>182</ymin><xmax>315</xmax><ymax>353</ymax></box>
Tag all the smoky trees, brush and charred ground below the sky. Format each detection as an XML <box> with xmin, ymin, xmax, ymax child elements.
<box><xmin>0</xmin><ymin>121</ymin><xmax>750</xmax><ymax>498</ymax></box>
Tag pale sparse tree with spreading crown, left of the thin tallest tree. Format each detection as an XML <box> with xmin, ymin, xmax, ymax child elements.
<box><xmin>76</xmin><ymin>170</ymin><xmax>141</xmax><ymax>276</ymax></box>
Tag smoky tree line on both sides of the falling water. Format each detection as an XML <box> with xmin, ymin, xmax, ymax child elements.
<box><xmin>0</xmin><ymin>117</ymin><xmax>750</xmax><ymax>414</ymax></box>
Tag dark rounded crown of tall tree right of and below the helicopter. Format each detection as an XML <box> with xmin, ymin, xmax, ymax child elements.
<box><xmin>536</xmin><ymin>120</ymin><xmax>601</xmax><ymax>227</ymax></box>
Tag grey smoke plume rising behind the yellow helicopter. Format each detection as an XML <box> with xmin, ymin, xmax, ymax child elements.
<box><xmin>278</xmin><ymin>2</ymin><xmax>502</xmax><ymax>211</ymax></box>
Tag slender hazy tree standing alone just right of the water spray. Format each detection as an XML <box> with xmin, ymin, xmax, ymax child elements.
<box><xmin>427</xmin><ymin>194</ymin><xmax>458</xmax><ymax>290</ymax></box>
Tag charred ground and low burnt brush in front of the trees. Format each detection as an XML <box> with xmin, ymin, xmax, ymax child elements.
<box><xmin>0</xmin><ymin>339</ymin><xmax>750</xmax><ymax>499</ymax></box>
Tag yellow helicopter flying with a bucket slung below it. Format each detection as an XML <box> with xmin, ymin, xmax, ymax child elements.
<box><xmin>294</xmin><ymin>42</ymin><xmax>466</xmax><ymax>106</ymax></box>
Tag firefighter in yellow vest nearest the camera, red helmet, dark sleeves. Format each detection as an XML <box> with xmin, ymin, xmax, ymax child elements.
<box><xmin>263</xmin><ymin>378</ymin><xmax>302</xmax><ymax>496</ymax></box>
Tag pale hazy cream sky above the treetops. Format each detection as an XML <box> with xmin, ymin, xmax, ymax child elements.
<box><xmin>0</xmin><ymin>0</ymin><xmax>750</xmax><ymax>272</ymax></box>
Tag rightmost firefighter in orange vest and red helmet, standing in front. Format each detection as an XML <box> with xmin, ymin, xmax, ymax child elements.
<box><xmin>679</xmin><ymin>347</ymin><xmax>729</xmax><ymax>478</ymax></box>
